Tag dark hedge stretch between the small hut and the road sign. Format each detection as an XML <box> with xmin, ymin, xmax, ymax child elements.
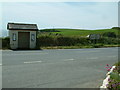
<box><xmin>37</xmin><ymin>36</ymin><xmax>90</xmax><ymax>46</ymax></box>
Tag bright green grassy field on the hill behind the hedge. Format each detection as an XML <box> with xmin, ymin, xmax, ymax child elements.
<box><xmin>41</xmin><ymin>29</ymin><xmax>119</xmax><ymax>36</ymax></box>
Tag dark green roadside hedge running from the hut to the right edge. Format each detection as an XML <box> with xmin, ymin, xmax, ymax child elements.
<box><xmin>37</xmin><ymin>35</ymin><xmax>118</xmax><ymax>47</ymax></box>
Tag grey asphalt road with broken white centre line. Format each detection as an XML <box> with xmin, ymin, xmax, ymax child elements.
<box><xmin>1</xmin><ymin>47</ymin><xmax>118</xmax><ymax>88</ymax></box>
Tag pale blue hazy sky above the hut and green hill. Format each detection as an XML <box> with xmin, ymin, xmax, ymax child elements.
<box><xmin>0</xmin><ymin>2</ymin><xmax>118</xmax><ymax>36</ymax></box>
